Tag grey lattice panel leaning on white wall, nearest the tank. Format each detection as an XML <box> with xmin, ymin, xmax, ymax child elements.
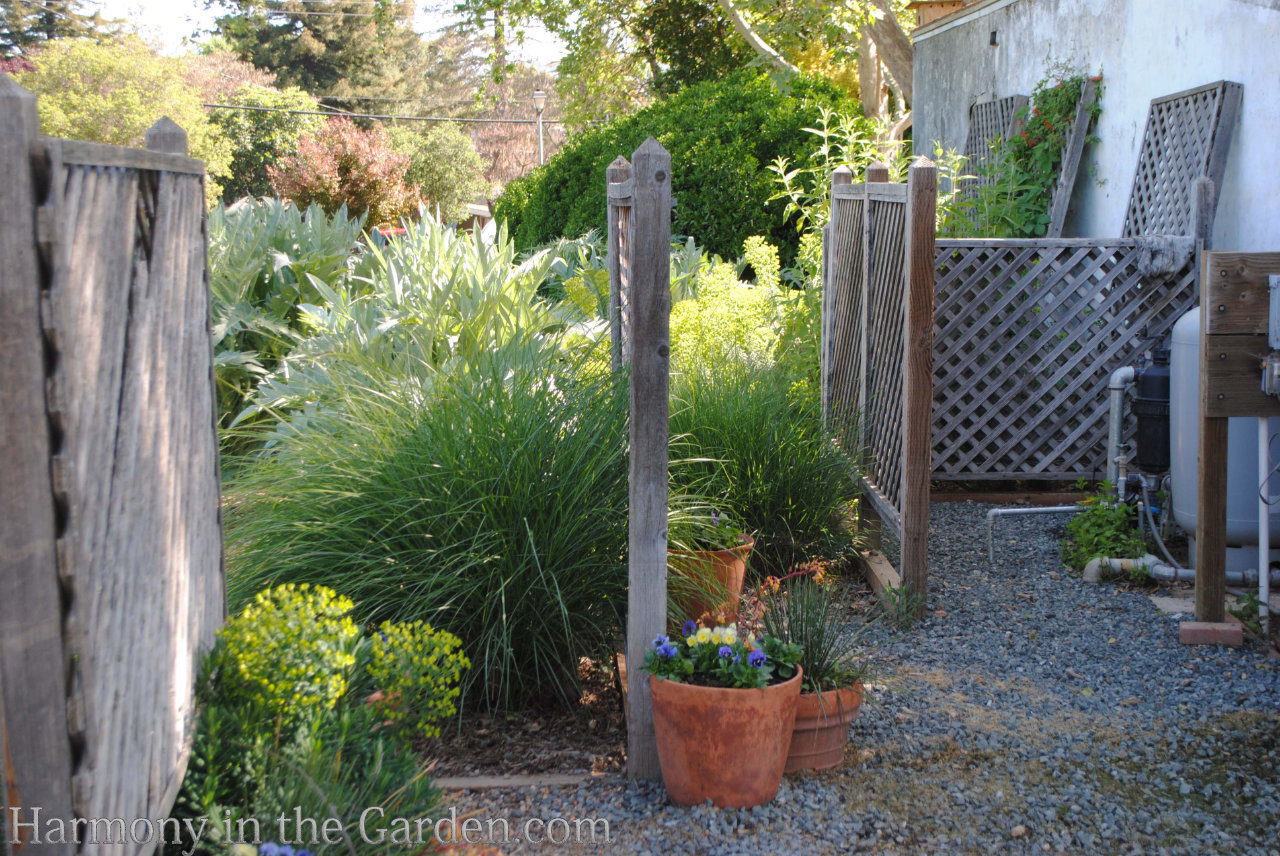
<box><xmin>1121</xmin><ymin>81</ymin><xmax>1242</xmax><ymax>238</ymax></box>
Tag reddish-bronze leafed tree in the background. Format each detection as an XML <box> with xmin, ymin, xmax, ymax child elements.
<box><xmin>266</xmin><ymin>119</ymin><xmax>417</xmax><ymax>225</ymax></box>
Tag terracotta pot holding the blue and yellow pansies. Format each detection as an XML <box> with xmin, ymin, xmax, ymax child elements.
<box><xmin>649</xmin><ymin>673</ymin><xmax>800</xmax><ymax>809</ymax></box>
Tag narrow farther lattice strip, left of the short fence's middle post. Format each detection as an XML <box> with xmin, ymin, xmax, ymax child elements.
<box><xmin>827</xmin><ymin>194</ymin><xmax>865</xmax><ymax>449</ymax></box>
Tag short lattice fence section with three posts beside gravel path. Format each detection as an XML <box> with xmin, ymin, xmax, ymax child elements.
<box><xmin>822</xmin><ymin>159</ymin><xmax>937</xmax><ymax>595</ymax></box>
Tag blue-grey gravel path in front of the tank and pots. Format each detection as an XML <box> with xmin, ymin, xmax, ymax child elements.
<box><xmin>445</xmin><ymin>503</ymin><xmax>1280</xmax><ymax>856</ymax></box>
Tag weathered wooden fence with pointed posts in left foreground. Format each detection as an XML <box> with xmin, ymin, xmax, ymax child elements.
<box><xmin>0</xmin><ymin>74</ymin><xmax>224</xmax><ymax>855</ymax></box>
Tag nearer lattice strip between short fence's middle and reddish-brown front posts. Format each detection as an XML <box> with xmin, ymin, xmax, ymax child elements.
<box><xmin>863</xmin><ymin>196</ymin><xmax>906</xmax><ymax>509</ymax></box>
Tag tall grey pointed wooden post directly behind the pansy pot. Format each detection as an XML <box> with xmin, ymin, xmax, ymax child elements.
<box><xmin>627</xmin><ymin>137</ymin><xmax>671</xmax><ymax>779</ymax></box>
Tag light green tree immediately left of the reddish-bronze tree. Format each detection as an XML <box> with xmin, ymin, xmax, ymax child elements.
<box><xmin>211</xmin><ymin>84</ymin><xmax>323</xmax><ymax>201</ymax></box>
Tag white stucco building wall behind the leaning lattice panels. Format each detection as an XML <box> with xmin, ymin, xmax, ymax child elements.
<box><xmin>911</xmin><ymin>0</ymin><xmax>1280</xmax><ymax>251</ymax></box>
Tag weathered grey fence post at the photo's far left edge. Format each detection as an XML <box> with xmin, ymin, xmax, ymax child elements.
<box><xmin>0</xmin><ymin>74</ymin><xmax>76</xmax><ymax>853</ymax></box>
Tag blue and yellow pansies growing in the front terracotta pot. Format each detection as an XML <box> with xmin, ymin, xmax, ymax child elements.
<box><xmin>645</xmin><ymin>621</ymin><xmax>801</xmax><ymax>688</ymax></box>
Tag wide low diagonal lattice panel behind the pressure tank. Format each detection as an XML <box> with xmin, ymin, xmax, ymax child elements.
<box><xmin>933</xmin><ymin>239</ymin><xmax>1196</xmax><ymax>480</ymax></box>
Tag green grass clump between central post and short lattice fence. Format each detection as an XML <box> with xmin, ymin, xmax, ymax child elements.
<box><xmin>671</xmin><ymin>358</ymin><xmax>858</xmax><ymax>573</ymax></box>
